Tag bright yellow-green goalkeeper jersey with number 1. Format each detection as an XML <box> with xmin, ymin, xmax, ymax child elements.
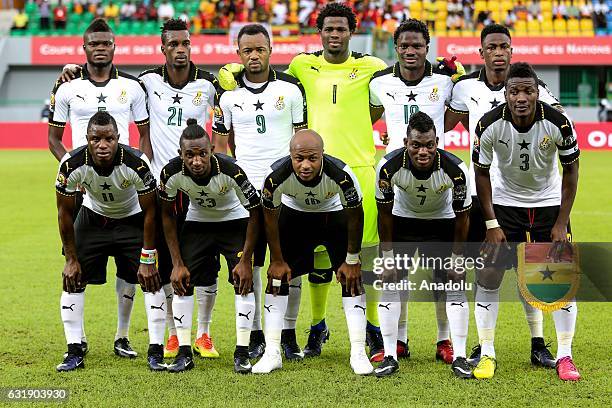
<box><xmin>287</xmin><ymin>51</ymin><xmax>387</xmax><ymax>167</ymax></box>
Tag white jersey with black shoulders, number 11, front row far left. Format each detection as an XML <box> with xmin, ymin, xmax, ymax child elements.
<box><xmin>55</xmin><ymin>144</ymin><xmax>155</xmax><ymax>219</ymax></box>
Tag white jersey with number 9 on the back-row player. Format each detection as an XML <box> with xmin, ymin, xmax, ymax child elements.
<box><xmin>213</xmin><ymin>69</ymin><xmax>308</xmax><ymax>187</ymax></box>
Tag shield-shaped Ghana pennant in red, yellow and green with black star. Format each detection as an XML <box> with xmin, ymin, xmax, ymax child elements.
<box><xmin>517</xmin><ymin>242</ymin><xmax>580</xmax><ymax>312</ymax></box>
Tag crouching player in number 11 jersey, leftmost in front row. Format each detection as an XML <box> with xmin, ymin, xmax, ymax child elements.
<box><xmin>56</xmin><ymin>111</ymin><xmax>166</xmax><ymax>371</ymax></box>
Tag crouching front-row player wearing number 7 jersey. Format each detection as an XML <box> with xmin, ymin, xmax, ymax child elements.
<box><xmin>375</xmin><ymin>112</ymin><xmax>472</xmax><ymax>378</ymax></box>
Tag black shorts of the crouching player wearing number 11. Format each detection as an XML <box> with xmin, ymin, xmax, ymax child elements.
<box><xmin>74</xmin><ymin>207</ymin><xmax>144</xmax><ymax>285</ymax></box>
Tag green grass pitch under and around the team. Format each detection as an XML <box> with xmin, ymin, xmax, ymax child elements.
<box><xmin>0</xmin><ymin>151</ymin><xmax>612</xmax><ymax>407</ymax></box>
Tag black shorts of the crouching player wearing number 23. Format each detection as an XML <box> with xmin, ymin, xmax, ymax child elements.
<box><xmin>179</xmin><ymin>218</ymin><xmax>249</xmax><ymax>292</ymax></box>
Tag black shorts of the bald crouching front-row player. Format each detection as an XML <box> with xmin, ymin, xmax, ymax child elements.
<box><xmin>278</xmin><ymin>205</ymin><xmax>348</xmax><ymax>278</ymax></box>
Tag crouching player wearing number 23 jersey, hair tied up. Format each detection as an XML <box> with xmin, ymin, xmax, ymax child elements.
<box><xmin>159</xmin><ymin>119</ymin><xmax>260</xmax><ymax>373</ymax></box>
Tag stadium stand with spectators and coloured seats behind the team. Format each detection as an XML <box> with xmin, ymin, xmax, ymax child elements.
<box><xmin>5</xmin><ymin>0</ymin><xmax>612</xmax><ymax>37</ymax></box>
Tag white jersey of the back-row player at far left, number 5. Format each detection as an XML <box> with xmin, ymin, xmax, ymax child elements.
<box><xmin>49</xmin><ymin>64</ymin><xmax>149</xmax><ymax>149</ymax></box>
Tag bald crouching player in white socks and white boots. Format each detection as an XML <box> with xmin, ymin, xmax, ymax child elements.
<box><xmin>253</xmin><ymin>130</ymin><xmax>373</xmax><ymax>374</ymax></box>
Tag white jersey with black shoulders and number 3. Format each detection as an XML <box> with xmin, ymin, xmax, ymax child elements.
<box><xmin>472</xmin><ymin>102</ymin><xmax>580</xmax><ymax>208</ymax></box>
